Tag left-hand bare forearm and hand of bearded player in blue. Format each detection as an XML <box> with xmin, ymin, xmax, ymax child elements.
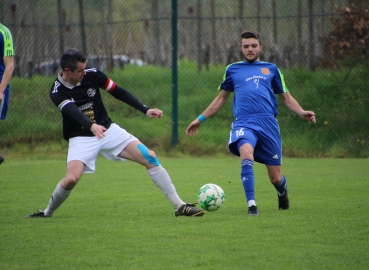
<box><xmin>186</xmin><ymin>90</ymin><xmax>231</xmax><ymax>136</ymax></box>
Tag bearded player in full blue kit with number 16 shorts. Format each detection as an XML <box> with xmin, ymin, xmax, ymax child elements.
<box><xmin>186</xmin><ymin>31</ymin><xmax>316</xmax><ymax>216</ymax></box>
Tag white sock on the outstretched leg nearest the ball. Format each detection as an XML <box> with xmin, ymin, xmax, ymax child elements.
<box><xmin>147</xmin><ymin>165</ymin><xmax>185</xmax><ymax>209</ymax></box>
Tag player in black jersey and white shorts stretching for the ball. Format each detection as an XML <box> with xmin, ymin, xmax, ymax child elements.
<box><xmin>26</xmin><ymin>49</ymin><xmax>204</xmax><ymax>217</ymax></box>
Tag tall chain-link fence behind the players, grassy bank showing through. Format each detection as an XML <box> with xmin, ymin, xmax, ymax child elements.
<box><xmin>0</xmin><ymin>0</ymin><xmax>369</xmax><ymax>157</ymax></box>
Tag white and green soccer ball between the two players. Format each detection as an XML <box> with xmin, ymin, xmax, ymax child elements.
<box><xmin>197</xmin><ymin>184</ymin><xmax>225</xmax><ymax>212</ymax></box>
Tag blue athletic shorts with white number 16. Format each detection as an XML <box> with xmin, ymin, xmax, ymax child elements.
<box><xmin>228</xmin><ymin>116</ymin><xmax>282</xmax><ymax>166</ymax></box>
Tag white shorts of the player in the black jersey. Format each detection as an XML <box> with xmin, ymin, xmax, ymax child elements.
<box><xmin>67</xmin><ymin>124</ymin><xmax>138</xmax><ymax>173</ymax></box>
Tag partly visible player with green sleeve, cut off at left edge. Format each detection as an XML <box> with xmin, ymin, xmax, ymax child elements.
<box><xmin>0</xmin><ymin>23</ymin><xmax>14</xmax><ymax>164</ymax></box>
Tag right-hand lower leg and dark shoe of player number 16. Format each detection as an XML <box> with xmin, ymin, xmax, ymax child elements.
<box><xmin>267</xmin><ymin>165</ymin><xmax>290</xmax><ymax>210</ymax></box>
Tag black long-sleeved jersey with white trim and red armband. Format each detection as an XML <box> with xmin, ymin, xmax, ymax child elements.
<box><xmin>50</xmin><ymin>68</ymin><xmax>148</xmax><ymax>141</ymax></box>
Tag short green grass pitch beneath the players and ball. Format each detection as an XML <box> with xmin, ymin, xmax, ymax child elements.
<box><xmin>0</xmin><ymin>156</ymin><xmax>369</xmax><ymax>270</ymax></box>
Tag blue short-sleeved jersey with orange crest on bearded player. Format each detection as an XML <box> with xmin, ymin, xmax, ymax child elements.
<box><xmin>219</xmin><ymin>61</ymin><xmax>288</xmax><ymax>119</ymax></box>
